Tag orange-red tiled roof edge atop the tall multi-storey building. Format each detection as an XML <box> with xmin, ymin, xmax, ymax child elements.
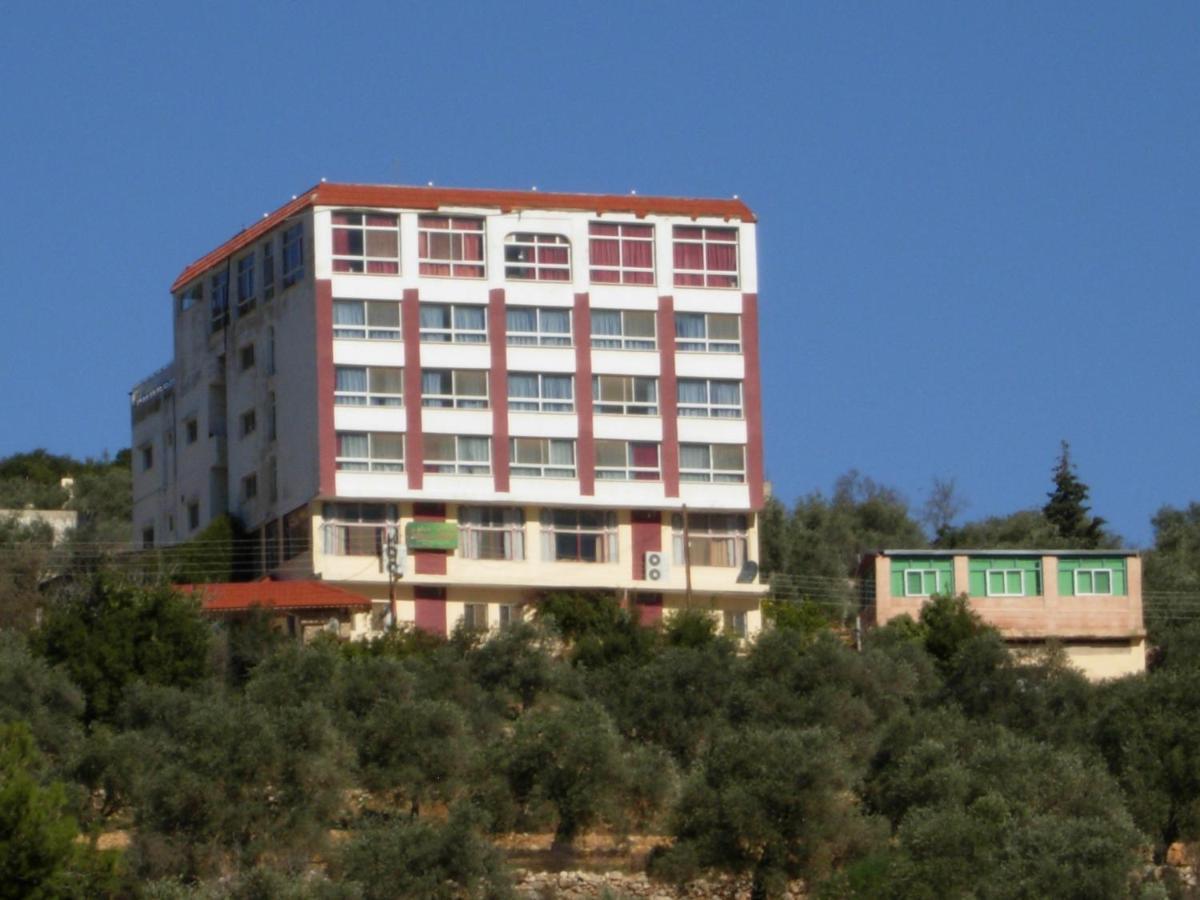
<box><xmin>170</xmin><ymin>182</ymin><xmax>757</xmax><ymax>292</ymax></box>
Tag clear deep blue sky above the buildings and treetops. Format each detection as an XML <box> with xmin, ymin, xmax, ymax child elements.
<box><xmin>0</xmin><ymin>0</ymin><xmax>1200</xmax><ymax>545</ymax></box>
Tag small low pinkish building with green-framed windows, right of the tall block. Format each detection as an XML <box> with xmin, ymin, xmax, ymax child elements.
<box><xmin>859</xmin><ymin>550</ymin><xmax>1146</xmax><ymax>679</ymax></box>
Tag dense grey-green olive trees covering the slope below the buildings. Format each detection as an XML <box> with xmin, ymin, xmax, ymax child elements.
<box><xmin>7</xmin><ymin>587</ymin><xmax>1200</xmax><ymax>898</ymax></box>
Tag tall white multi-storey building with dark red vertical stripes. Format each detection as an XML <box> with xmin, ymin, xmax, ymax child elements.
<box><xmin>132</xmin><ymin>184</ymin><xmax>764</xmax><ymax>631</ymax></box>
